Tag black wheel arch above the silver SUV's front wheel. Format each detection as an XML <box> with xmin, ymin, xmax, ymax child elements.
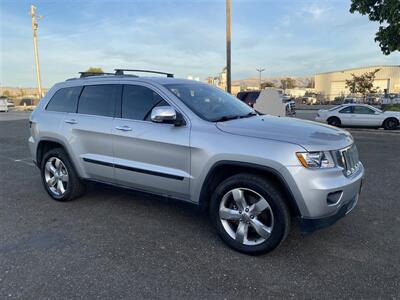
<box><xmin>199</xmin><ymin>160</ymin><xmax>301</xmax><ymax>216</ymax></box>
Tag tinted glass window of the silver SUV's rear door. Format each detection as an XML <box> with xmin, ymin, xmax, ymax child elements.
<box><xmin>78</xmin><ymin>84</ymin><xmax>118</xmax><ymax>117</ymax></box>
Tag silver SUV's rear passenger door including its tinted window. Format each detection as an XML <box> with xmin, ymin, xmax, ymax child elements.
<box><xmin>62</xmin><ymin>84</ymin><xmax>122</xmax><ymax>182</ymax></box>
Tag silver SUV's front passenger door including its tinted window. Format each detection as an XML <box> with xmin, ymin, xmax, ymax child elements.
<box><xmin>113</xmin><ymin>83</ymin><xmax>190</xmax><ymax>199</ymax></box>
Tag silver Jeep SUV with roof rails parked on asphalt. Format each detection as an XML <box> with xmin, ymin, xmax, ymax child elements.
<box><xmin>29</xmin><ymin>70</ymin><xmax>364</xmax><ymax>254</ymax></box>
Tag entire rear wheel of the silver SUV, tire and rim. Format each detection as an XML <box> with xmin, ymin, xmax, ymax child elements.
<box><xmin>40</xmin><ymin>148</ymin><xmax>85</xmax><ymax>202</ymax></box>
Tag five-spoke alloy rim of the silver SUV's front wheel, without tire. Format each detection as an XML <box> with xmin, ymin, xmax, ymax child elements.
<box><xmin>219</xmin><ymin>188</ymin><xmax>274</xmax><ymax>246</ymax></box>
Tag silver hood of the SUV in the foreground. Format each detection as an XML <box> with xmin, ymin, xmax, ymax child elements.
<box><xmin>216</xmin><ymin>115</ymin><xmax>353</xmax><ymax>151</ymax></box>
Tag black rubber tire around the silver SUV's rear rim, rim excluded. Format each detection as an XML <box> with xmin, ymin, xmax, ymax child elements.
<box><xmin>40</xmin><ymin>148</ymin><xmax>85</xmax><ymax>202</ymax></box>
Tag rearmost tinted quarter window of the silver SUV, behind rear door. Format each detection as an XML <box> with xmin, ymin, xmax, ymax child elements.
<box><xmin>46</xmin><ymin>86</ymin><xmax>82</xmax><ymax>112</ymax></box>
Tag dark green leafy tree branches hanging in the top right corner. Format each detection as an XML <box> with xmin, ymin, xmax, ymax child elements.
<box><xmin>350</xmin><ymin>0</ymin><xmax>400</xmax><ymax>55</ymax></box>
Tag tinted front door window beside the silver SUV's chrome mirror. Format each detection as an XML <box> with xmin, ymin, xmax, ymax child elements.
<box><xmin>122</xmin><ymin>85</ymin><xmax>168</xmax><ymax>120</ymax></box>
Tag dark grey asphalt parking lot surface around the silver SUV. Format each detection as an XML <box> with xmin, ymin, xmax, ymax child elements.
<box><xmin>0</xmin><ymin>113</ymin><xmax>400</xmax><ymax>299</ymax></box>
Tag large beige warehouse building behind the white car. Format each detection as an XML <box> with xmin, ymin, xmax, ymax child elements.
<box><xmin>315</xmin><ymin>65</ymin><xmax>400</xmax><ymax>100</ymax></box>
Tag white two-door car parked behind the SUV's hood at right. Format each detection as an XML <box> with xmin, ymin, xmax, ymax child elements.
<box><xmin>315</xmin><ymin>104</ymin><xmax>400</xmax><ymax>130</ymax></box>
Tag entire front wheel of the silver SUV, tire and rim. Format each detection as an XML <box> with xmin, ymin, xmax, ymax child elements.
<box><xmin>210</xmin><ymin>173</ymin><xmax>290</xmax><ymax>255</ymax></box>
